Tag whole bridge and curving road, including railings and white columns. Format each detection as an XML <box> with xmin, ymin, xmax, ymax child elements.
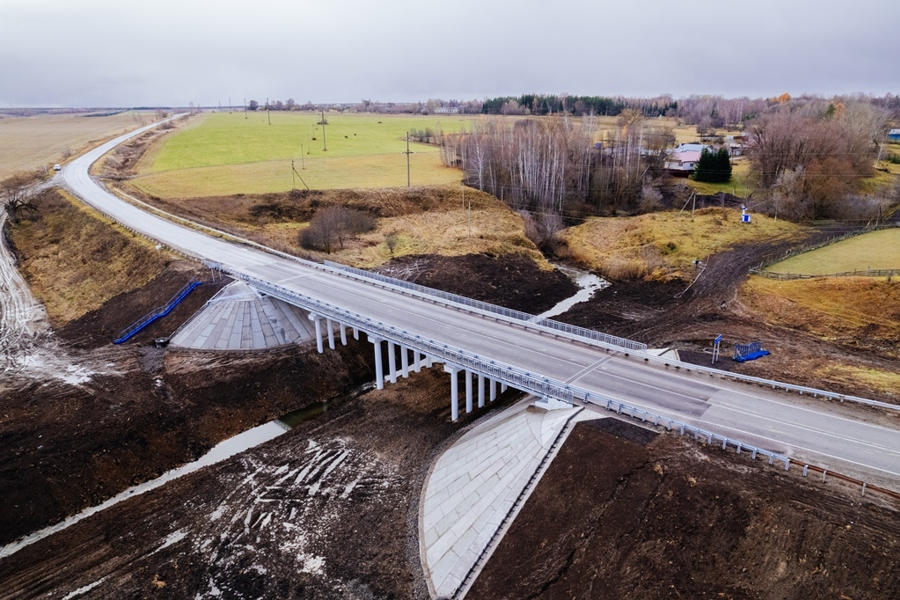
<box><xmin>62</xmin><ymin>118</ymin><xmax>900</xmax><ymax>487</ymax></box>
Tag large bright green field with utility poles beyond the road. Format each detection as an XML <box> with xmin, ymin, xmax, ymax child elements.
<box><xmin>132</xmin><ymin>112</ymin><xmax>464</xmax><ymax>198</ymax></box>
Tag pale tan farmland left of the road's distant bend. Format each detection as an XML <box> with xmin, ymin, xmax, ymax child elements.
<box><xmin>0</xmin><ymin>111</ymin><xmax>153</xmax><ymax>179</ymax></box>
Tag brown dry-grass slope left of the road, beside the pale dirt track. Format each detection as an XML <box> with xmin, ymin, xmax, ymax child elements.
<box><xmin>11</xmin><ymin>191</ymin><xmax>170</xmax><ymax>327</ymax></box>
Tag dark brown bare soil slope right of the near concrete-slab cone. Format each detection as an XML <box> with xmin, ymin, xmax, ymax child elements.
<box><xmin>467</xmin><ymin>419</ymin><xmax>900</xmax><ymax>600</ymax></box>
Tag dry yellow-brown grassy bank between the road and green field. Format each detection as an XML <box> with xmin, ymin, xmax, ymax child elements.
<box><xmin>129</xmin><ymin>185</ymin><xmax>550</xmax><ymax>269</ymax></box>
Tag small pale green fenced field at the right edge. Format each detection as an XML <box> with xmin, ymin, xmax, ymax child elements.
<box><xmin>767</xmin><ymin>228</ymin><xmax>900</xmax><ymax>275</ymax></box>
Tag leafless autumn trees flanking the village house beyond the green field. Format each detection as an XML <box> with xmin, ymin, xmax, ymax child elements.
<box><xmin>439</xmin><ymin>94</ymin><xmax>900</xmax><ymax>229</ymax></box>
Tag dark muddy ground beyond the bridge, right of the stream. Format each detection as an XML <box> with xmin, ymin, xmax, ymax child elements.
<box><xmin>555</xmin><ymin>230</ymin><xmax>900</xmax><ymax>404</ymax></box>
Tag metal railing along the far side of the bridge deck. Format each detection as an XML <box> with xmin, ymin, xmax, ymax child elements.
<box><xmin>324</xmin><ymin>260</ymin><xmax>647</xmax><ymax>351</ymax></box>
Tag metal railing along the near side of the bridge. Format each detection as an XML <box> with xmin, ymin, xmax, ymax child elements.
<box><xmin>211</xmin><ymin>267</ymin><xmax>790</xmax><ymax>468</ymax></box>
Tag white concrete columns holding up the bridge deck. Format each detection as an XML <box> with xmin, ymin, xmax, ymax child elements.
<box><xmin>309</xmin><ymin>313</ymin><xmax>507</xmax><ymax>421</ymax></box>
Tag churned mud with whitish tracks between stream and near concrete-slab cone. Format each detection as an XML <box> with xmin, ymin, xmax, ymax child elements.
<box><xmin>0</xmin><ymin>352</ymin><xmax>524</xmax><ymax>599</ymax></box>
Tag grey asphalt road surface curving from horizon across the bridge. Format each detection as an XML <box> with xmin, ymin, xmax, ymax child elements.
<box><xmin>62</xmin><ymin>118</ymin><xmax>900</xmax><ymax>489</ymax></box>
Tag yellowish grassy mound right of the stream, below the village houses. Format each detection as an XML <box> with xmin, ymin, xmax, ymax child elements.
<box><xmin>563</xmin><ymin>208</ymin><xmax>801</xmax><ymax>279</ymax></box>
